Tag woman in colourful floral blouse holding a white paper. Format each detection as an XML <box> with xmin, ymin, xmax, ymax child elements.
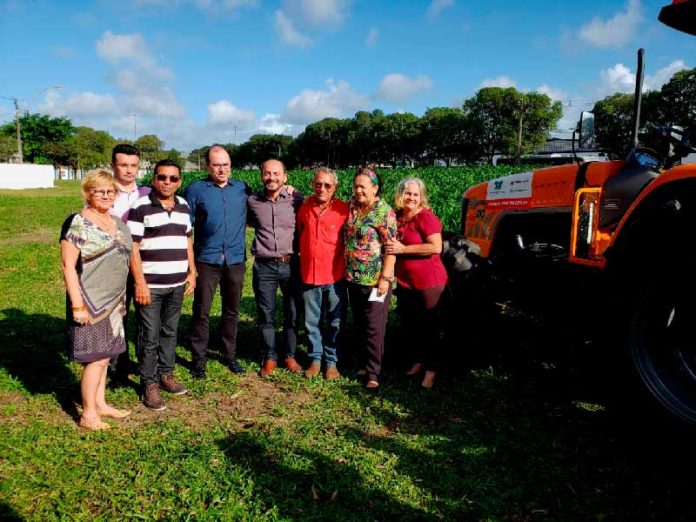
<box><xmin>344</xmin><ymin>168</ymin><xmax>396</xmax><ymax>389</ymax></box>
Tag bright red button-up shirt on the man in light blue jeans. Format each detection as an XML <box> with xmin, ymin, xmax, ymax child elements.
<box><xmin>295</xmin><ymin>196</ymin><xmax>348</xmax><ymax>285</ymax></box>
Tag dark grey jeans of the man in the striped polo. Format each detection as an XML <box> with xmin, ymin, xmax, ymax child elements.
<box><xmin>135</xmin><ymin>285</ymin><xmax>185</xmax><ymax>385</ymax></box>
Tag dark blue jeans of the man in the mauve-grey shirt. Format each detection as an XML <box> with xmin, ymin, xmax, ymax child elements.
<box><xmin>252</xmin><ymin>260</ymin><xmax>300</xmax><ymax>361</ymax></box>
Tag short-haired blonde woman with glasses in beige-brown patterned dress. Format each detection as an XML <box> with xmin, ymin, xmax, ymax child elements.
<box><xmin>60</xmin><ymin>169</ymin><xmax>132</xmax><ymax>430</ymax></box>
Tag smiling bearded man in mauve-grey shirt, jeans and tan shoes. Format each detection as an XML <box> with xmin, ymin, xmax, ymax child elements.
<box><xmin>248</xmin><ymin>156</ymin><xmax>302</xmax><ymax>377</ymax></box>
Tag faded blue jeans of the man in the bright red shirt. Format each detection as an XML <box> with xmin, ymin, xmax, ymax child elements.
<box><xmin>302</xmin><ymin>281</ymin><xmax>348</xmax><ymax>368</ymax></box>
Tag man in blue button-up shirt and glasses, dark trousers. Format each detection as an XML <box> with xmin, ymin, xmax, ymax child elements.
<box><xmin>184</xmin><ymin>145</ymin><xmax>251</xmax><ymax>379</ymax></box>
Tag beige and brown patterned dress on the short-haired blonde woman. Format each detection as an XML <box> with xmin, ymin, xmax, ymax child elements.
<box><xmin>60</xmin><ymin>214</ymin><xmax>133</xmax><ymax>363</ymax></box>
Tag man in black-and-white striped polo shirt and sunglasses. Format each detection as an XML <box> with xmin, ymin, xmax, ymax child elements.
<box><xmin>128</xmin><ymin>159</ymin><xmax>196</xmax><ymax>411</ymax></box>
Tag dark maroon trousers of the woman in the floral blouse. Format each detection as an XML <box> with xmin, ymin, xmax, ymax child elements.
<box><xmin>348</xmin><ymin>283</ymin><xmax>392</xmax><ymax>380</ymax></box>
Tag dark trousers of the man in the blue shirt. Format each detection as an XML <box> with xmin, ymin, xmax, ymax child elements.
<box><xmin>191</xmin><ymin>262</ymin><xmax>245</xmax><ymax>364</ymax></box>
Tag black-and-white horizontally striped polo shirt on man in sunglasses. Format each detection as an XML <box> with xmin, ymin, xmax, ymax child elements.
<box><xmin>128</xmin><ymin>193</ymin><xmax>191</xmax><ymax>288</ymax></box>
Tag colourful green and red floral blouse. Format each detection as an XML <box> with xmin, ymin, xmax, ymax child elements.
<box><xmin>343</xmin><ymin>199</ymin><xmax>396</xmax><ymax>286</ymax></box>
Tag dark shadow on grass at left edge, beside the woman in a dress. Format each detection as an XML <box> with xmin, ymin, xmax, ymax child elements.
<box><xmin>0</xmin><ymin>308</ymin><xmax>79</xmax><ymax>418</ymax></box>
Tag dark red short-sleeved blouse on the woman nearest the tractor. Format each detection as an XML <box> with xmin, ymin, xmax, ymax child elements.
<box><xmin>394</xmin><ymin>208</ymin><xmax>447</xmax><ymax>290</ymax></box>
